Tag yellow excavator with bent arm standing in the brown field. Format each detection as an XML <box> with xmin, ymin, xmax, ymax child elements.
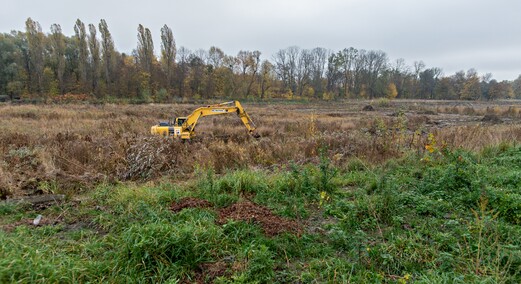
<box><xmin>150</xmin><ymin>101</ymin><xmax>258</xmax><ymax>140</ymax></box>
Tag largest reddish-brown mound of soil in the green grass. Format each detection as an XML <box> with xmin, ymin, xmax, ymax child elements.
<box><xmin>218</xmin><ymin>201</ymin><xmax>301</xmax><ymax>236</ymax></box>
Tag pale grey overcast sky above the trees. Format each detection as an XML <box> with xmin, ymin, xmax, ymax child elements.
<box><xmin>0</xmin><ymin>0</ymin><xmax>521</xmax><ymax>80</ymax></box>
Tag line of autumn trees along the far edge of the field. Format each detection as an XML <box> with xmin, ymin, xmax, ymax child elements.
<box><xmin>0</xmin><ymin>18</ymin><xmax>521</xmax><ymax>102</ymax></box>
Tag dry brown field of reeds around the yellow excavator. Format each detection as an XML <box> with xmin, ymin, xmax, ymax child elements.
<box><xmin>0</xmin><ymin>100</ymin><xmax>521</xmax><ymax>199</ymax></box>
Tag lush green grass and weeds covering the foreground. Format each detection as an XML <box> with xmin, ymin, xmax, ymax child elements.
<box><xmin>0</xmin><ymin>145</ymin><xmax>521</xmax><ymax>283</ymax></box>
